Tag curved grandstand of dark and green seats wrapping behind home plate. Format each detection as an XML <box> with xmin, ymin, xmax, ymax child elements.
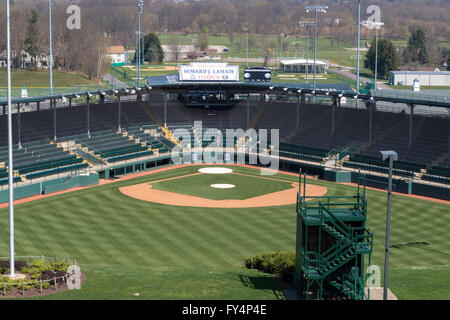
<box><xmin>0</xmin><ymin>95</ymin><xmax>449</xmax><ymax>185</ymax></box>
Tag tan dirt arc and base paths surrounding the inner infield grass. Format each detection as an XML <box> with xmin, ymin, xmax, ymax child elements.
<box><xmin>119</xmin><ymin>174</ymin><xmax>327</xmax><ymax>208</ymax></box>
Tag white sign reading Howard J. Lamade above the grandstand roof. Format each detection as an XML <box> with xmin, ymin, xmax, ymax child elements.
<box><xmin>179</xmin><ymin>62</ymin><xmax>239</xmax><ymax>82</ymax></box>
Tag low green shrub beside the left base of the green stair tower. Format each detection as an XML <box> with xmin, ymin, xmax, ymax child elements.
<box><xmin>244</xmin><ymin>251</ymin><xmax>295</xmax><ymax>281</ymax></box>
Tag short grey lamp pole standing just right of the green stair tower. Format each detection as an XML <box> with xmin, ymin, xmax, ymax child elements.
<box><xmin>380</xmin><ymin>151</ymin><xmax>398</xmax><ymax>300</ymax></box>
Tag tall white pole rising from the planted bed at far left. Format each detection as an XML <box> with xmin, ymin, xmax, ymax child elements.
<box><xmin>6</xmin><ymin>0</ymin><xmax>16</xmax><ymax>277</ymax></box>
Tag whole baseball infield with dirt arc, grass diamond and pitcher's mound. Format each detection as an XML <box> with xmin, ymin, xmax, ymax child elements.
<box><xmin>119</xmin><ymin>167</ymin><xmax>327</xmax><ymax>208</ymax></box>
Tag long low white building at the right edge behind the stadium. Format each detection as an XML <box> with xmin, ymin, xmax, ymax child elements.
<box><xmin>389</xmin><ymin>71</ymin><xmax>450</xmax><ymax>87</ymax></box>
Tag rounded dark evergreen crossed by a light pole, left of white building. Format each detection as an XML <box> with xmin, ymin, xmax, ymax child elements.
<box><xmin>364</xmin><ymin>39</ymin><xmax>399</xmax><ymax>79</ymax></box>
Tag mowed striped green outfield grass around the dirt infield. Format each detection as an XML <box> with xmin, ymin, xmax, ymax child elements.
<box><xmin>0</xmin><ymin>167</ymin><xmax>450</xmax><ymax>299</ymax></box>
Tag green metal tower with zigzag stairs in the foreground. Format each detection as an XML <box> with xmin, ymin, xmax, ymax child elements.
<box><xmin>296</xmin><ymin>172</ymin><xmax>373</xmax><ymax>300</ymax></box>
